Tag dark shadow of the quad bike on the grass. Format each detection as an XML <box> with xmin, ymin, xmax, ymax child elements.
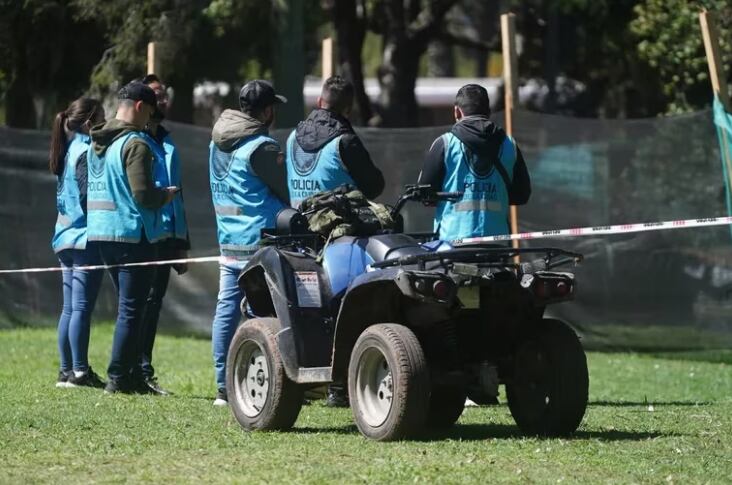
<box><xmin>290</xmin><ymin>424</ymin><xmax>678</xmax><ymax>442</ymax></box>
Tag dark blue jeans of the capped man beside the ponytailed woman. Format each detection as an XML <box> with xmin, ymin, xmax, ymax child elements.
<box><xmin>98</xmin><ymin>242</ymin><xmax>155</xmax><ymax>382</ymax></box>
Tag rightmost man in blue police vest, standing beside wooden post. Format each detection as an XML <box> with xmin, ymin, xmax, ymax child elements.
<box><xmin>419</xmin><ymin>84</ymin><xmax>531</xmax><ymax>241</ymax></box>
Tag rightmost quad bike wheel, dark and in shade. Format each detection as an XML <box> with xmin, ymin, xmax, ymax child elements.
<box><xmin>506</xmin><ymin>319</ymin><xmax>589</xmax><ymax>436</ymax></box>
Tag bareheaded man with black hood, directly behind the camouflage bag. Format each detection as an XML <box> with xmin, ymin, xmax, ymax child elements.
<box><xmin>287</xmin><ymin>76</ymin><xmax>384</xmax><ymax>208</ymax></box>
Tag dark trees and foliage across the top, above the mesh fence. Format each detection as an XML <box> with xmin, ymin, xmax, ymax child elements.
<box><xmin>0</xmin><ymin>0</ymin><xmax>732</xmax><ymax>127</ymax></box>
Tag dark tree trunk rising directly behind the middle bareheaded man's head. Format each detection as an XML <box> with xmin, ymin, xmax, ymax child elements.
<box><xmin>333</xmin><ymin>0</ymin><xmax>373</xmax><ymax>125</ymax></box>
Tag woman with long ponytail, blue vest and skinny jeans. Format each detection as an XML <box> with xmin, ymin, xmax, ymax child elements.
<box><xmin>49</xmin><ymin>98</ymin><xmax>104</xmax><ymax>387</ymax></box>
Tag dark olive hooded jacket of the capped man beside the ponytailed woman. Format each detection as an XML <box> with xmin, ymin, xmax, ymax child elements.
<box><xmin>90</xmin><ymin>119</ymin><xmax>167</xmax><ymax>209</ymax></box>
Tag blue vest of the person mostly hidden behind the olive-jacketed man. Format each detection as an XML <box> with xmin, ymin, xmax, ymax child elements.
<box><xmin>143</xmin><ymin>132</ymin><xmax>188</xmax><ymax>241</ymax></box>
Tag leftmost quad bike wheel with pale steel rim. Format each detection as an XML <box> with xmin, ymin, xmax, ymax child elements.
<box><xmin>226</xmin><ymin>318</ymin><xmax>303</xmax><ymax>430</ymax></box>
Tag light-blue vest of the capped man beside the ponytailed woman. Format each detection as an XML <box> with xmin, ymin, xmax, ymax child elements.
<box><xmin>87</xmin><ymin>132</ymin><xmax>163</xmax><ymax>243</ymax></box>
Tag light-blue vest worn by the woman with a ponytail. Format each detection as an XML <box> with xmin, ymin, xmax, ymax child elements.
<box><xmin>51</xmin><ymin>132</ymin><xmax>91</xmax><ymax>253</ymax></box>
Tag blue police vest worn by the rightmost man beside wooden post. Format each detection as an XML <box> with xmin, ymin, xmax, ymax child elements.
<box><xmin>434</xmin><ymin>133</ymin><xmax>516</xmax><ymax>241</ymax></box>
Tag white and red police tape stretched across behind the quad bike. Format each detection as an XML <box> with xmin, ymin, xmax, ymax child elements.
<box><xmin>0</xmin><ymin>217</ymin><xmax>732</xmax><ymax>274</ymax></box>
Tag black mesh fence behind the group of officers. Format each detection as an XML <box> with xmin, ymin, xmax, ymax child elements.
<box><xmin>0</xmin><ymin>111</ymin><xmax>732</xmax><ymax>349</ymax></box>
